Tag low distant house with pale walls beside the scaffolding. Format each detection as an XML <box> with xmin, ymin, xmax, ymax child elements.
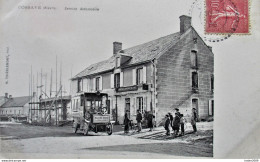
<box><xmin>0</xmin><ymin>95</ymin><xmax>32</xmax><ymax>118</ymax></box>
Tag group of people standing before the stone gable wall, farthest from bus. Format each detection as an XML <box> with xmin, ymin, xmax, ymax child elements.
<box><xmin>164</xmin><ymin>108</ymin><xmax>197</xmax><ymax>136</ymax></box>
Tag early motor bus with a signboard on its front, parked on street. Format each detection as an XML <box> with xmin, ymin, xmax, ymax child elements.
<box><xmin>72</xmin><ymin>92</ymin><xmax>114</xmax><ymax>135</ymax></box>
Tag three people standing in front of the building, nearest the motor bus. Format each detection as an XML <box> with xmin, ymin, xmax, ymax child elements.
<box><xmin>124</xmin><ymin>110</ymin><xmax>155</xmax><ymax>133</ymax></box>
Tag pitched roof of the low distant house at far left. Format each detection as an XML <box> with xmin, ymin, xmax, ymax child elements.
<box><xmin>1</xmin><ymin>96</ymin><xmax>31</xmax><ymax>108</ymax></box>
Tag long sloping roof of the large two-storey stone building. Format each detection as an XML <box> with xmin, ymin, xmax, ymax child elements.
<box><xmin>72</xmin><ymin>32</ymin><xmax>181</xmax><ymax>79</ymax></box>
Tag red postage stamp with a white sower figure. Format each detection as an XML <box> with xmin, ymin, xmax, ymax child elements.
<box><xmin>205</xmin><ymin>0</ymin><xmax>249</xmax><ymax>34</ymax></box>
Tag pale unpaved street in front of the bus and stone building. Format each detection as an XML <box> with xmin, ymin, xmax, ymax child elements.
<box><xmin>0</xmin><ymin>122</ymin><xmax>213</xmax><ymax>158</ymax></box>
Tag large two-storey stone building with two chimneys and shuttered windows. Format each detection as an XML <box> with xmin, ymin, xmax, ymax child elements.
<box><xmin>71</xmin><ymin>15</ymin><xmax>214</xmax><ymax>124</ymax></box>
